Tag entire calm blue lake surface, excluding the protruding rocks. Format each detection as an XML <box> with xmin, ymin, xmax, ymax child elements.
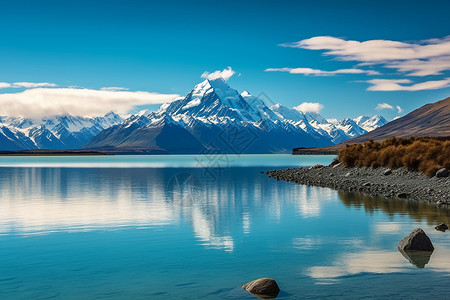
<box><xmin>0</xmin><ymin>155</ymin><xmax>450</xmax><ymax>299</ymax></box>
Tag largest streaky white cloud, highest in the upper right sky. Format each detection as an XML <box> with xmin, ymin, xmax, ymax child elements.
<box><xmin>280</xmin><ymin>36</ymin><xmax>450</xmax><ymax>76</ymax></box>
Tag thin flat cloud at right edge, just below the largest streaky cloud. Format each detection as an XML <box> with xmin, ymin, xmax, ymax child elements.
<box><xmin>366</xmin><ymin>78</ymin><xmax>450</xmax><ymax>92</ymax></box>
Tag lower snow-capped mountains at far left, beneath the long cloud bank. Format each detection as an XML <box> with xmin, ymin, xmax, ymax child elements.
<box><xmin>0</xmin><ymin>112</ymin><xmax>122</xmax><ymax>151</ymax></box>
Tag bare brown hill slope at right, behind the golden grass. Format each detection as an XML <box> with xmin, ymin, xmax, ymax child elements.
<box><xmin>342</xmin><ymin>97</ymin><xmax>450</xmax><ymax>144</ymax></box>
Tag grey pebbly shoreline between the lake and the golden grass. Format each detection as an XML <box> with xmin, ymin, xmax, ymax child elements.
<box><xmin>265</xmin><ymin>164</ymin><xmax>450</xmax><ymax>207</ymax></box>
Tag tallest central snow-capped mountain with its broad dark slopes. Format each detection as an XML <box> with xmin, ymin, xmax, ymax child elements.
<box><xmin>85</xmin><ymin>78</ymin><xmax>384</xmax><ymax>154</ymax></box>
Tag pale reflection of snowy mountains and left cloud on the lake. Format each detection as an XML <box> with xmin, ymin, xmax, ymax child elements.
<box><xmin>0</xmin><ymin>168</ymin><xmax>336</xmax><ymax>251</ymax></box>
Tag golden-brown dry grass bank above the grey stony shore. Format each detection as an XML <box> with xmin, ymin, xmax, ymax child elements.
<box><xmin>339</xmin><ymin>137</ymin><xmax>450</xmax><ymax>177</ymax></box>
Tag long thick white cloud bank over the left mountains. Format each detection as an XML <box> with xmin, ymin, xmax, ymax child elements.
<box><xmin>0</xmin><ymin>88</ymin><xmax>179</xmax><ymax>119</ymax></box>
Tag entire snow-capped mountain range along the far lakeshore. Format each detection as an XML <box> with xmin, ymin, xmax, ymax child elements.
<box><xmin>0</xmin><ymin>78</ymin><xmax>387</xmax><ymax>154</ymax></box>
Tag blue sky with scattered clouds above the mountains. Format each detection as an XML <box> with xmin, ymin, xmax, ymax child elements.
<box><xmin>0</xmin><ymin>0</ymin><xmax>450</xmax><ymax>119</ymax></box>
